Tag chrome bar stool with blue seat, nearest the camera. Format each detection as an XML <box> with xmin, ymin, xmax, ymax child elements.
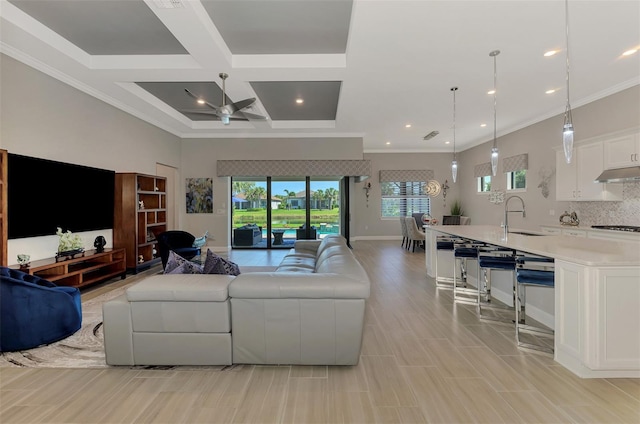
<box><xmin>516</xmin><ymin>255</ymin><xmax>555</xmax><ymax>353</ymax></box>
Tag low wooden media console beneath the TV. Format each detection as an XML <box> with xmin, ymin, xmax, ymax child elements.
<box><xmin>11</xmin><ymin>249</ymin><xmax>127</xmax><ymax>287</ymax></box>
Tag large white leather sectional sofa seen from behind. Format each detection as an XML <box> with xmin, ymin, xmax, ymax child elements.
<box><xmin>103</xmin><ymin>235</ymin><xmax>370</xmax><ymax>365</ymax></box>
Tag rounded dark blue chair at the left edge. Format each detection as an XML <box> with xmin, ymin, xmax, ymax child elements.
<box><xmin>0</xmin><ymin>267</ymin><xmax>82</xmax><ymax>352</ymax></box>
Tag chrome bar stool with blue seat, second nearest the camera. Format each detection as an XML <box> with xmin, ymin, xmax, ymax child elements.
<box><xmin>477</xmin><ymin>246</ymin><xmax>516</xmax><ymax>324</ymax></box>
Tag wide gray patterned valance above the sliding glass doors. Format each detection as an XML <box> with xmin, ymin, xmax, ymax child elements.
<box><xmin>216</xmin><ymin>160</ymin><xmax>371</xmax><ymax>181</ymax></box>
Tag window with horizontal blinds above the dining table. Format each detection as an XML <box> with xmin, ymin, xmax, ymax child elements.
<box><xmin>380</xmin><ymin>181</ymin><xmax>431</xmax><ymax>218</ymax></box>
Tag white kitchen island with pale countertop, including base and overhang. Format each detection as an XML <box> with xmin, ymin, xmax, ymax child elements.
<box><xmin>425</xmin><ymin>225</ymin><xmax>640</xmax><ymax>378</ymax></box>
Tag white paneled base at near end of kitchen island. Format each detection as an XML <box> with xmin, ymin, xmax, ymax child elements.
<box><xmin>555</xmin><ymin>260</ymin><xmax>640</xmax><ymax>378</ymax></box>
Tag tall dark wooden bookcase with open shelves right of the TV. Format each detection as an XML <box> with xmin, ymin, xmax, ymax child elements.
<box><xmin>113</xmin><ymin>173</ymin><xmax>167</xmax><ymax>272</ymax></box>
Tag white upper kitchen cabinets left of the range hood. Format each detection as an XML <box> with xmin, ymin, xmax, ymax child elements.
<box><xmin>556</xmin><ymin>141</ymin><xmax>622</xmax><ymax>201</ymax></box>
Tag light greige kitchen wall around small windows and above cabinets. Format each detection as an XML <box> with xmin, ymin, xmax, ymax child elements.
<box><xmin>458</xmin><ymin>86</ymin><xmax>640</xmax><ymax>230</ymax></box>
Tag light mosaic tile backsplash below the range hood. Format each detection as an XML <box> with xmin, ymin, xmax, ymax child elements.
<box><xmin>570</xmin><ymin>181</ymin><xmax>640</xmax><ymax>227</ymax></box>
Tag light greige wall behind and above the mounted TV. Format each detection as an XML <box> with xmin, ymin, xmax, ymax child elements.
<box><xmin>0</xmin><ymin>55</ymin><xmax>180</xmax><ymax>264</ymax></box>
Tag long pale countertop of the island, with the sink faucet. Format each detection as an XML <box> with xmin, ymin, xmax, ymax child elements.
<box><xmin>425</xmin><ymin>225</ymin><xmax>640</xmax><ymax>267</ymax></box>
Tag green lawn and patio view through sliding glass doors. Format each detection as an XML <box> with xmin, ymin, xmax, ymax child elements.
<box><xmin>231</xmin><ymin>177</ymin><xmax>340</xmax><ymax>249</ymax></box>
